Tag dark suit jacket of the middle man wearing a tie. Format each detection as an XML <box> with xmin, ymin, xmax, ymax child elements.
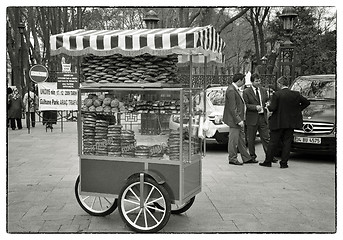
<box><xmin>243</xmin><ymin>86</ymin><xmax>268</xmax><ymax>125</ymax></box>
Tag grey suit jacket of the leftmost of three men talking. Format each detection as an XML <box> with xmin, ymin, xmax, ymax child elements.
<box><xmin>223</xmin><ymin>84</ymin><xmax>245</xmax><ymax>128</ymax></box>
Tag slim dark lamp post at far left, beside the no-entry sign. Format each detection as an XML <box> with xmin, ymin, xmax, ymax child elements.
<box><xmin>18</xmin><ymin>22</ymin><xmax>30</xmax><ymax>133</ymax></box>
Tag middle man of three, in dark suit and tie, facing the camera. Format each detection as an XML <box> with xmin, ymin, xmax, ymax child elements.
<box><xmin>243</xmin><ymin>73</ymin><xmax>269</xmax><ymax>160</ymax></box>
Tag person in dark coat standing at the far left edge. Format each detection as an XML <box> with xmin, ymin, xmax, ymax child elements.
<box><xmin>8</xmin><ymin>88</ymin><xmax>24</xmax><ymax>130</ymax></box>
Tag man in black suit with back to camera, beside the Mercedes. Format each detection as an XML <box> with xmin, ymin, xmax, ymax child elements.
<box><xmin>260</xmin><ymin>77</ymin><xmax>310</xmax><ymax>168</ymax></box>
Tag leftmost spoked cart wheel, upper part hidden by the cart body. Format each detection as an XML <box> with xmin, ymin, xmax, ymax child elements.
<box><xmin>75</xmin><ymin>176</ymin><xmax>117</xmax><ymax>216</ymax></box>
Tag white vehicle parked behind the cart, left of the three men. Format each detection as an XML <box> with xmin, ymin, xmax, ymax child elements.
<box><xmin>169</xmin><ymin>85</ymin><xmax>230</xmax><ymax>144</ymax></box>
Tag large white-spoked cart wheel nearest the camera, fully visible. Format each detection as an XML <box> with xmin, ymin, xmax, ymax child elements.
<box><xmin>119</xmin><ymin>177</ymin><xmax>171</xmax><ymax>232</ymax></box>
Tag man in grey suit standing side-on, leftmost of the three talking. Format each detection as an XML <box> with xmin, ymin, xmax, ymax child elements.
<box><xmin>223</xmin><ymin>73</ymin><xmax>257</xmax><ymax>165</ymax></box>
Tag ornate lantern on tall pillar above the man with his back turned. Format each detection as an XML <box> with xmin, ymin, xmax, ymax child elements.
<box><xmin>275</xmin><ymin>7</ymin><xmax>298</xmax><ymax>87</ymax></box>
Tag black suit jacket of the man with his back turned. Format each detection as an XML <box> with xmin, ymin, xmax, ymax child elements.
<box><xmin>268</xmin><ymin>88</ymin><xmax>310</xmax><ymax>130</ymax></box>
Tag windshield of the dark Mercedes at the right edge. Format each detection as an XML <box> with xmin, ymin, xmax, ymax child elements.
<box><xmin>292</xmin><ymin>78</ymin><xmax>335</xmax><ymax>99</ymax></box>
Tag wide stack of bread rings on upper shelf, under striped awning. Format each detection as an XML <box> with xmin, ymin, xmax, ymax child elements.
<box><xmin>81</xmin><ymin>54</ymin><xmax>179</xmax><ymax>85</ymax></box>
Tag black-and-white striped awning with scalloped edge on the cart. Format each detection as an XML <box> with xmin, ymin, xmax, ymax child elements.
<box><xmin>50</xmin><ymin>25</ymin><xmax>225</xmax><ymax>62</ymax></box>
